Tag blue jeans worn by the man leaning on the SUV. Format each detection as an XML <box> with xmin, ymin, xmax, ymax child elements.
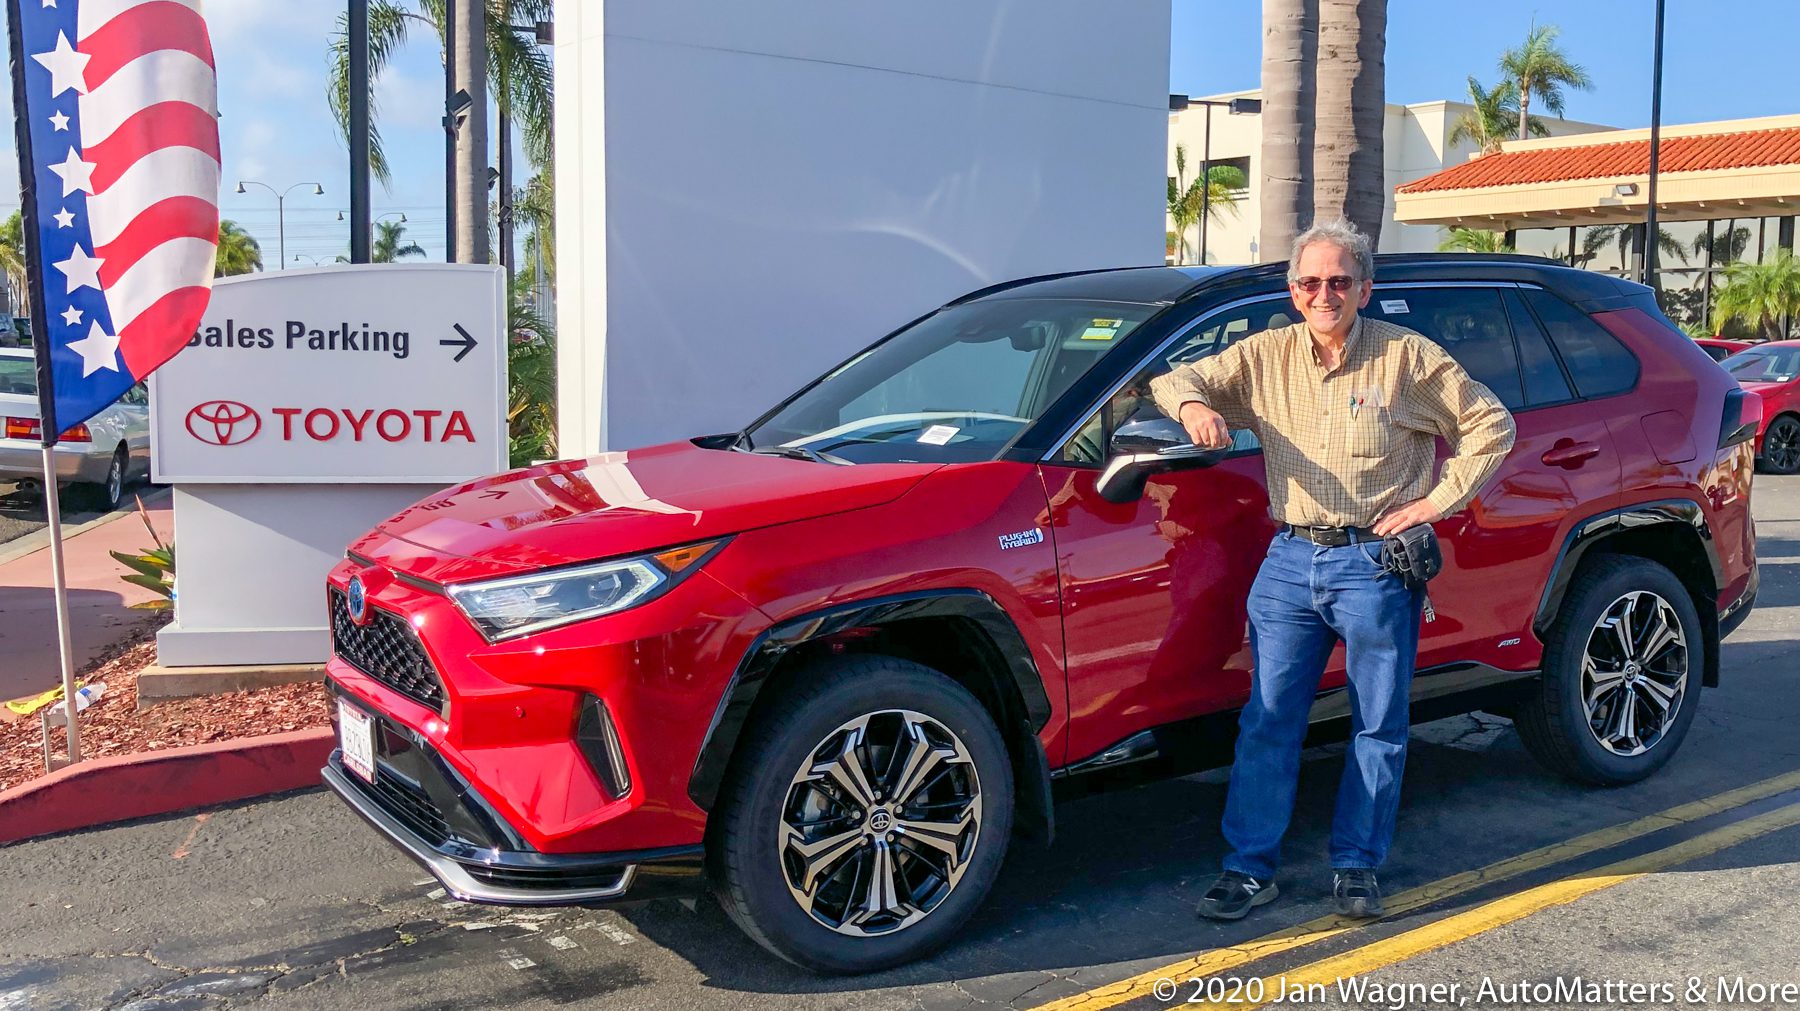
<box><xmin>1222</xmin><ymin>531</ymin><xmax>1422</xmax><ymax>880</ymax></box>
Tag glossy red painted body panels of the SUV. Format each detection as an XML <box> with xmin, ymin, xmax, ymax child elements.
<box><xmin>326</xmin><ymin>257</ymin><xmax>1769</xmax><ymax>895</ymax></box>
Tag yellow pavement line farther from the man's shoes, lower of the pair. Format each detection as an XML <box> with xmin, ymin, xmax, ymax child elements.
<box><xmin>1199</xmin><ymin>804</ymin><xmax>1800</xmax><ymax>1011</ymax></box>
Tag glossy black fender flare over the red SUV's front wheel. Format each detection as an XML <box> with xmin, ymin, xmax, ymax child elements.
<box><xmin>688</xmin><ymin>588</ymin><xmax>1051</xmax><ymax>811</ymax></box>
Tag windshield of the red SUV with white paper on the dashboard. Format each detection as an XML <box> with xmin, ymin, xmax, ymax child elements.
<box><xmin>745</xmin><ymin>299</ymin><xmax>1157</xmax><ymax>464</ymax></box>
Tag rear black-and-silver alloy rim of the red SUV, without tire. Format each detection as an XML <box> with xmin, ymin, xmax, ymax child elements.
<box><xmin>1580</xmin><ymin>590</ymin><xmax>1688</xmax><ymax>757</ymax></box>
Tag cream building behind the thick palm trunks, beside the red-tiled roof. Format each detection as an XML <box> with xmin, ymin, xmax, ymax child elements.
<box><xmin>1166</xmin><ymin>90</ymin><xmax>1611</xmax><ymax>263</ymax></box>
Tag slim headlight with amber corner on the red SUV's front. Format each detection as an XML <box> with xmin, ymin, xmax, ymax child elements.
<box><xmin>448</xmin><ymin>540</ymin><xmax>725</xmax><ymax>642</ymax></box>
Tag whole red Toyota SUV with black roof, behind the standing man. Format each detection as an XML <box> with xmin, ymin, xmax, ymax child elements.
<box><xmin>324</xmin><ymin>255</ymin><xmax>1759</xmax><ymax>971</ymax></box>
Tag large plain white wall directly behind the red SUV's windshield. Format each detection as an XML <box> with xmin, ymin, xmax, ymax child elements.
<box><xmin>556</xmin><ymin>0</ymin><xmax>1170</xmax><ymax>455</ymax></box>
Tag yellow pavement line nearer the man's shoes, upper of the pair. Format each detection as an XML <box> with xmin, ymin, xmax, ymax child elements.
<box><xmin>1035</xmin><ymin>772</ymin><xmax>1800</xmax><ymax>1011</ymax></box>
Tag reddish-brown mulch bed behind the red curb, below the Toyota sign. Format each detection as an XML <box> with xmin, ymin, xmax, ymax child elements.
<box><xmin>0</xmin><ymin>613</ymin><xmax>331</xmax><ymax>790</ymax></box>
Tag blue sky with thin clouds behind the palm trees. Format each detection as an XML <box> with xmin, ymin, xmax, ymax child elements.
<box><xmin>0</xmin><ymin>0</ymin><xmax>1800</xmax><ymax>268</ymax></box>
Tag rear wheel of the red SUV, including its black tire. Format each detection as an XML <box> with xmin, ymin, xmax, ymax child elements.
<box><xmin>1514</xmin><ymin>556</ymin><xmax>1715</xmax><ymax>786</ymax></box>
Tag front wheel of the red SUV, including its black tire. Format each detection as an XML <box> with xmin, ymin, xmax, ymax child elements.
<box><xmin>707</xmin><ymin>657</ymin><xmax>1013</xmax><ymax>973</ymax></box>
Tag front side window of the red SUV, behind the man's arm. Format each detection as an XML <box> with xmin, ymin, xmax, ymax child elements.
<box><xmin>1055</xmin><ymin>295</ymin><xmax>1300</xmax><ymax>466</ymax></box>
